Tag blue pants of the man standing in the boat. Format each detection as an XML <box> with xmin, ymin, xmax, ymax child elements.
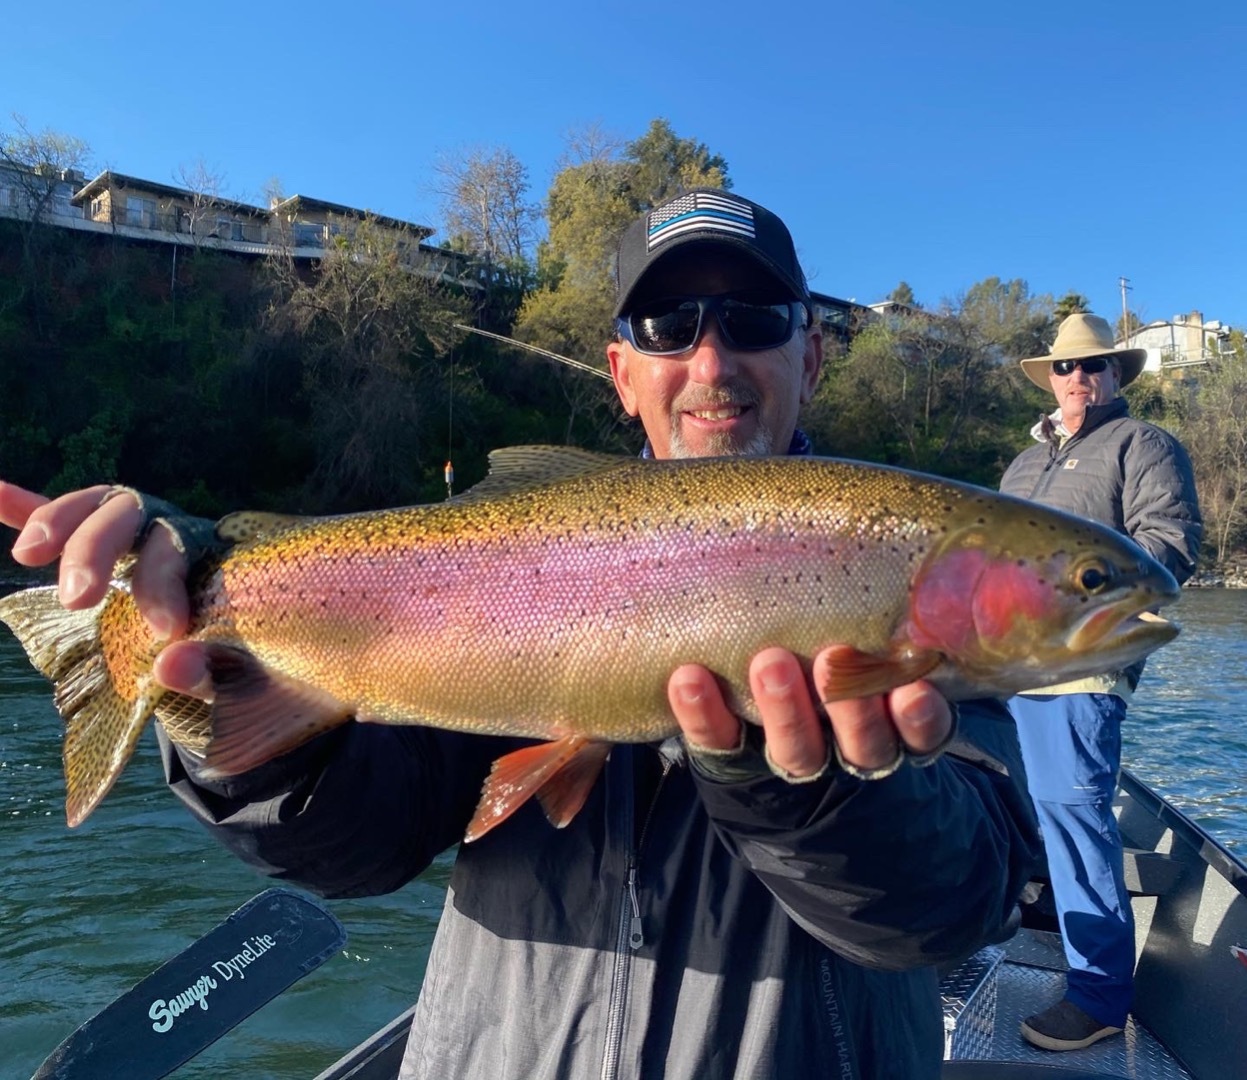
<box><xmin>1008</xmin><ymin>693</ymin><xmax>1135</xmax><ymax>1028</ymax></box>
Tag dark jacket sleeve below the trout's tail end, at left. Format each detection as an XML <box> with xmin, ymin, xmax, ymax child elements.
<box><xmin>157</xmin><ymin>722</ymin><xmax>504</xmax><ymax>898</ymax></box>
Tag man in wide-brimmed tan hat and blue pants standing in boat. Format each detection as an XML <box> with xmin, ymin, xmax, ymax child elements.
<box><xmin>1000</xmin><ymin>314</ymin><xmax>1202</xmax><ymax>1050</ymax></box>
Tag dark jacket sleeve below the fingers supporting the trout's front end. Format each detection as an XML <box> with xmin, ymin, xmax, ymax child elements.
<box><xmin>693</xmin><ymin>701</ymin><xmax>1039</xmax><ymax>970</ymax></box>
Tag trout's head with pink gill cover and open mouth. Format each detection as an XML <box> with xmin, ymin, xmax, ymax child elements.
<box><xmin>905</xmin><ymin>503</ymin><xmax>1180</xmax><ymax>697</ymax></box>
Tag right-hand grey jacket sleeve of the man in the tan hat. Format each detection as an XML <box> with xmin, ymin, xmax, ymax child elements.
<box><xmin>1121</xmin><ymin>427</ymin><xmax>1203</xmax><ymax>585</ymax></box>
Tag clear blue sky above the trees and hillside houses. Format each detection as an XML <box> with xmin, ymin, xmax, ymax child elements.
<box><xmin>0</xmin><ymin>0</ymin><xmax>1247</xmax><ymax>327</ymax></box>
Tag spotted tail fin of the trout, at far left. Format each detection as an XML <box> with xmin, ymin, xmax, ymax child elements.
<box><xmin>0</xmin><ymin>586</ymin><xmax>166</xmax><ymax>828</ymax></box>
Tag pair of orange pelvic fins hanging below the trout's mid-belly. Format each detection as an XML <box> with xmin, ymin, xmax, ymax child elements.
<box><xmin>464</xmin><ymin>735</ymin><xmax>612</xmax><ymax>843</ymax></box>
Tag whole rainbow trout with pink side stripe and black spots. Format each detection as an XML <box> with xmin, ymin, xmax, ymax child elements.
<box><xmin>0</xmin><ymin>446</ymin><xmax>1178</xmax><ymax>839</ymax></box>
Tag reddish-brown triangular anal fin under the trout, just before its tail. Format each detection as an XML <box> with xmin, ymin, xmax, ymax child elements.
<box><xmin>205</xmin><ymin>645</ymin><xmax>352</xmax><ymax>777</ymax></box>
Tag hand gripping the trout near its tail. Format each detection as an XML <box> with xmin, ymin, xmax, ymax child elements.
<box><xmin>0</xmin><ymin>480</ymin><xmax>211</xmax><ymax>697</ymax></box>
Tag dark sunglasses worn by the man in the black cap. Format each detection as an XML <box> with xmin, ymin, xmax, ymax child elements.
<box><xmin>615</xmin><ymin>296</ymin><xmax>809</xmax><ymax>357</ymax></box>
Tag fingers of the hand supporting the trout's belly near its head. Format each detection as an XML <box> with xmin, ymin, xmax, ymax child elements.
<box><xmin>667</xmin><ymin>646</ymin><xmax>953</xmax><ymax>778</ymax></box>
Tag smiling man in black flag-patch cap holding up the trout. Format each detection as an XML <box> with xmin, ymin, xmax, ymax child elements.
<box><xmin>0</xmin><ymin>191</ymin><xmax>1036</xmax><ymax>1080</ymax></box>
